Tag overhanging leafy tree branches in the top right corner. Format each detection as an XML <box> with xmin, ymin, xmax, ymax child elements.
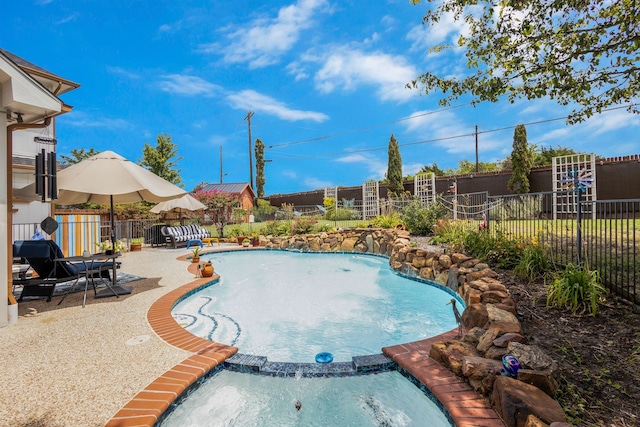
<box><xmin>408</xmin><ymin>0</ymin><xmax>640</xmax><ymax>123</ymax></box>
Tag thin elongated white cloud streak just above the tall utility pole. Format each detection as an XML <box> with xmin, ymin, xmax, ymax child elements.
<box><xmin>227</xmin><ymin>90</ymin><xmax>329</xmax><ymax>123</ymax></box>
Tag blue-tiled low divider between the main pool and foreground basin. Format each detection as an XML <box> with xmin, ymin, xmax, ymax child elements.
<box><xmin>224</xmin><ymin>353</ymin><xmax>396</xmax><ymax>377</ymax></box>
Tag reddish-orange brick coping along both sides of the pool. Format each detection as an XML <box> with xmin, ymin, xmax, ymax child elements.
<box><xmin>106</xmin><ymin>251</ymin><xmax>505</xmax><ymax>427</ymax></box>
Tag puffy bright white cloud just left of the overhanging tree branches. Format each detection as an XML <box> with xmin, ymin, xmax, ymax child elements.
<box><xmin>307</xmin><ymin>46</ymin><xmax>418</xmax><ymax>102</ymax></box>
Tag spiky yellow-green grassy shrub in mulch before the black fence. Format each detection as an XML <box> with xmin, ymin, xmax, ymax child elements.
<box><xmin>547</xmin><ymin>264</ymin><xmax>607</xmax><ymax>316</ymax></box>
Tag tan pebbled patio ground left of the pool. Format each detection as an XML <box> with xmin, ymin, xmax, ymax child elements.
<box><xmin>0</xmin><ymin>248</ymin><xmax>206</xmax><ymax>427</ymax></box>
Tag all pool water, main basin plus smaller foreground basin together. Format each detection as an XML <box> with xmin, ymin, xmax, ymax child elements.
<box><xmin>160</xmin><ymin>250</ymin><xmax>455</xmax><ymax>427</ymax></box>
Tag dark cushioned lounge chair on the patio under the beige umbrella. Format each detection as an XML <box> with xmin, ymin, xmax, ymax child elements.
<box><xmin>13</xmin><ymin>240</ymin><xmax>119</xmax><ymax>302</ymax></box>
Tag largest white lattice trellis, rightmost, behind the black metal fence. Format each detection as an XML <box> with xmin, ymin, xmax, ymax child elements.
<box><xmin>551</xmin><ymin>153</ymin><xmax>597</xmax><ymax>219</ymax></box>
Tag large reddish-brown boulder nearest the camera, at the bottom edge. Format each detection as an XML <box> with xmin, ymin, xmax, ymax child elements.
<box><xmin>491</xmin><ymin>376</ymin><xmax>567</xmax><ymax>427</ymax></box>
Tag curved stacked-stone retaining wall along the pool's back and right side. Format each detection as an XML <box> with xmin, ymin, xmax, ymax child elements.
<box><xmin>260</xmin><ymin>228</ymin><xmax>566</xmax><ymax>427</ymax></box>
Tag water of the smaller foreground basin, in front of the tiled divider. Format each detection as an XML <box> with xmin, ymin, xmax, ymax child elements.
<box><xmin>161</xmin><ymin>370</ymin><xmax>451</xmax><ymax>427</ymax></box>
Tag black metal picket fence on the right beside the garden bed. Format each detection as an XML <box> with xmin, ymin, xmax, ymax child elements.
<box><xmin>484</xmin><ymin>192</ymin><xmax>640</xmax><ymax>304</ymax></box>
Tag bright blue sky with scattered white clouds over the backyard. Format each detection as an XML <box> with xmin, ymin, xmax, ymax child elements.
<box><xmin>0</xmin><ymin>0</ymin><xmax>640</xmax><ymax>195</ymax></box>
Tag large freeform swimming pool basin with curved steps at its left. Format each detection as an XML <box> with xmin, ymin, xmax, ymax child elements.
<box><xmin>172</xmin><ymin>250</ymin><xmax>456</xmax><ymax>362</ymax></box>
